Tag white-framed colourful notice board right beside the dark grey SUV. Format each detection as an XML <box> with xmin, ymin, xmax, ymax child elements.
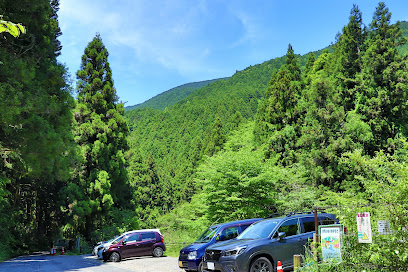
<box><xmin>319</xmin><ymin>224</ymin><xmax>344</xmax><ymax>262</ymax></box>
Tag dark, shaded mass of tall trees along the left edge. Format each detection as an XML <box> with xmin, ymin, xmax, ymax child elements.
<box><xmin>0</xmin><ymin>0</ymin><xmax>74</xmax><ymax>258</ymax></box>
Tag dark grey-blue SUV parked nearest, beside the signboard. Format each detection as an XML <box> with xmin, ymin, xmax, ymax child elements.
<box><xmin>203</xmin><ymin>213</ymin><xmax>338</xmax><ymax>272</ymax></box>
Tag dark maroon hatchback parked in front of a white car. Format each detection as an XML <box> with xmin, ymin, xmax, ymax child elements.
<box><xmin>102</xmin><ymin>229</ymin><xmax>166</xmax><ymax>262</ymax></box>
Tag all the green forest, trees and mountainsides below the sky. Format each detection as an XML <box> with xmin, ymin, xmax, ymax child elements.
<box><xmin>0</xmin><ymin>0</ymin><xmax>408</xmax><ymax>271</ymax></box>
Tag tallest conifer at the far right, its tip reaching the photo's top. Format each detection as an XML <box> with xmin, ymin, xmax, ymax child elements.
<box><xmin>356</xmin><ymin>2</ymin><xmax>408</xmax><ymax>151</ymax></box>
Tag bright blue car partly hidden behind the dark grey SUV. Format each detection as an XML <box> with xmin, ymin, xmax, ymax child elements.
<box><xmin>179</xmin><ymin>218</ymin><xmax>261</xmax><ymax>272</ymax></box>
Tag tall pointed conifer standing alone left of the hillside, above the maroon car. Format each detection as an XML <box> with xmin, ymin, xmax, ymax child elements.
<box><xmin>72</xmin><ymin>34</ymin><xmax>128</xmax><ymax>239</ymax></box>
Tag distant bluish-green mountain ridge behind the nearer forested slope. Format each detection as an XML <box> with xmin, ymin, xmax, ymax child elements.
<box><xmin>125</xmin><ymin>78</ymin><xmax>226</xmax><ymax>110</ymax></box>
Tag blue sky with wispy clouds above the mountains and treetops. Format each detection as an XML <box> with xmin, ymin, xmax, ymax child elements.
<box><xmin>58</xmin><ymin>0</ymin><xmax>408</xmax><ymax>106</ymax></box>
